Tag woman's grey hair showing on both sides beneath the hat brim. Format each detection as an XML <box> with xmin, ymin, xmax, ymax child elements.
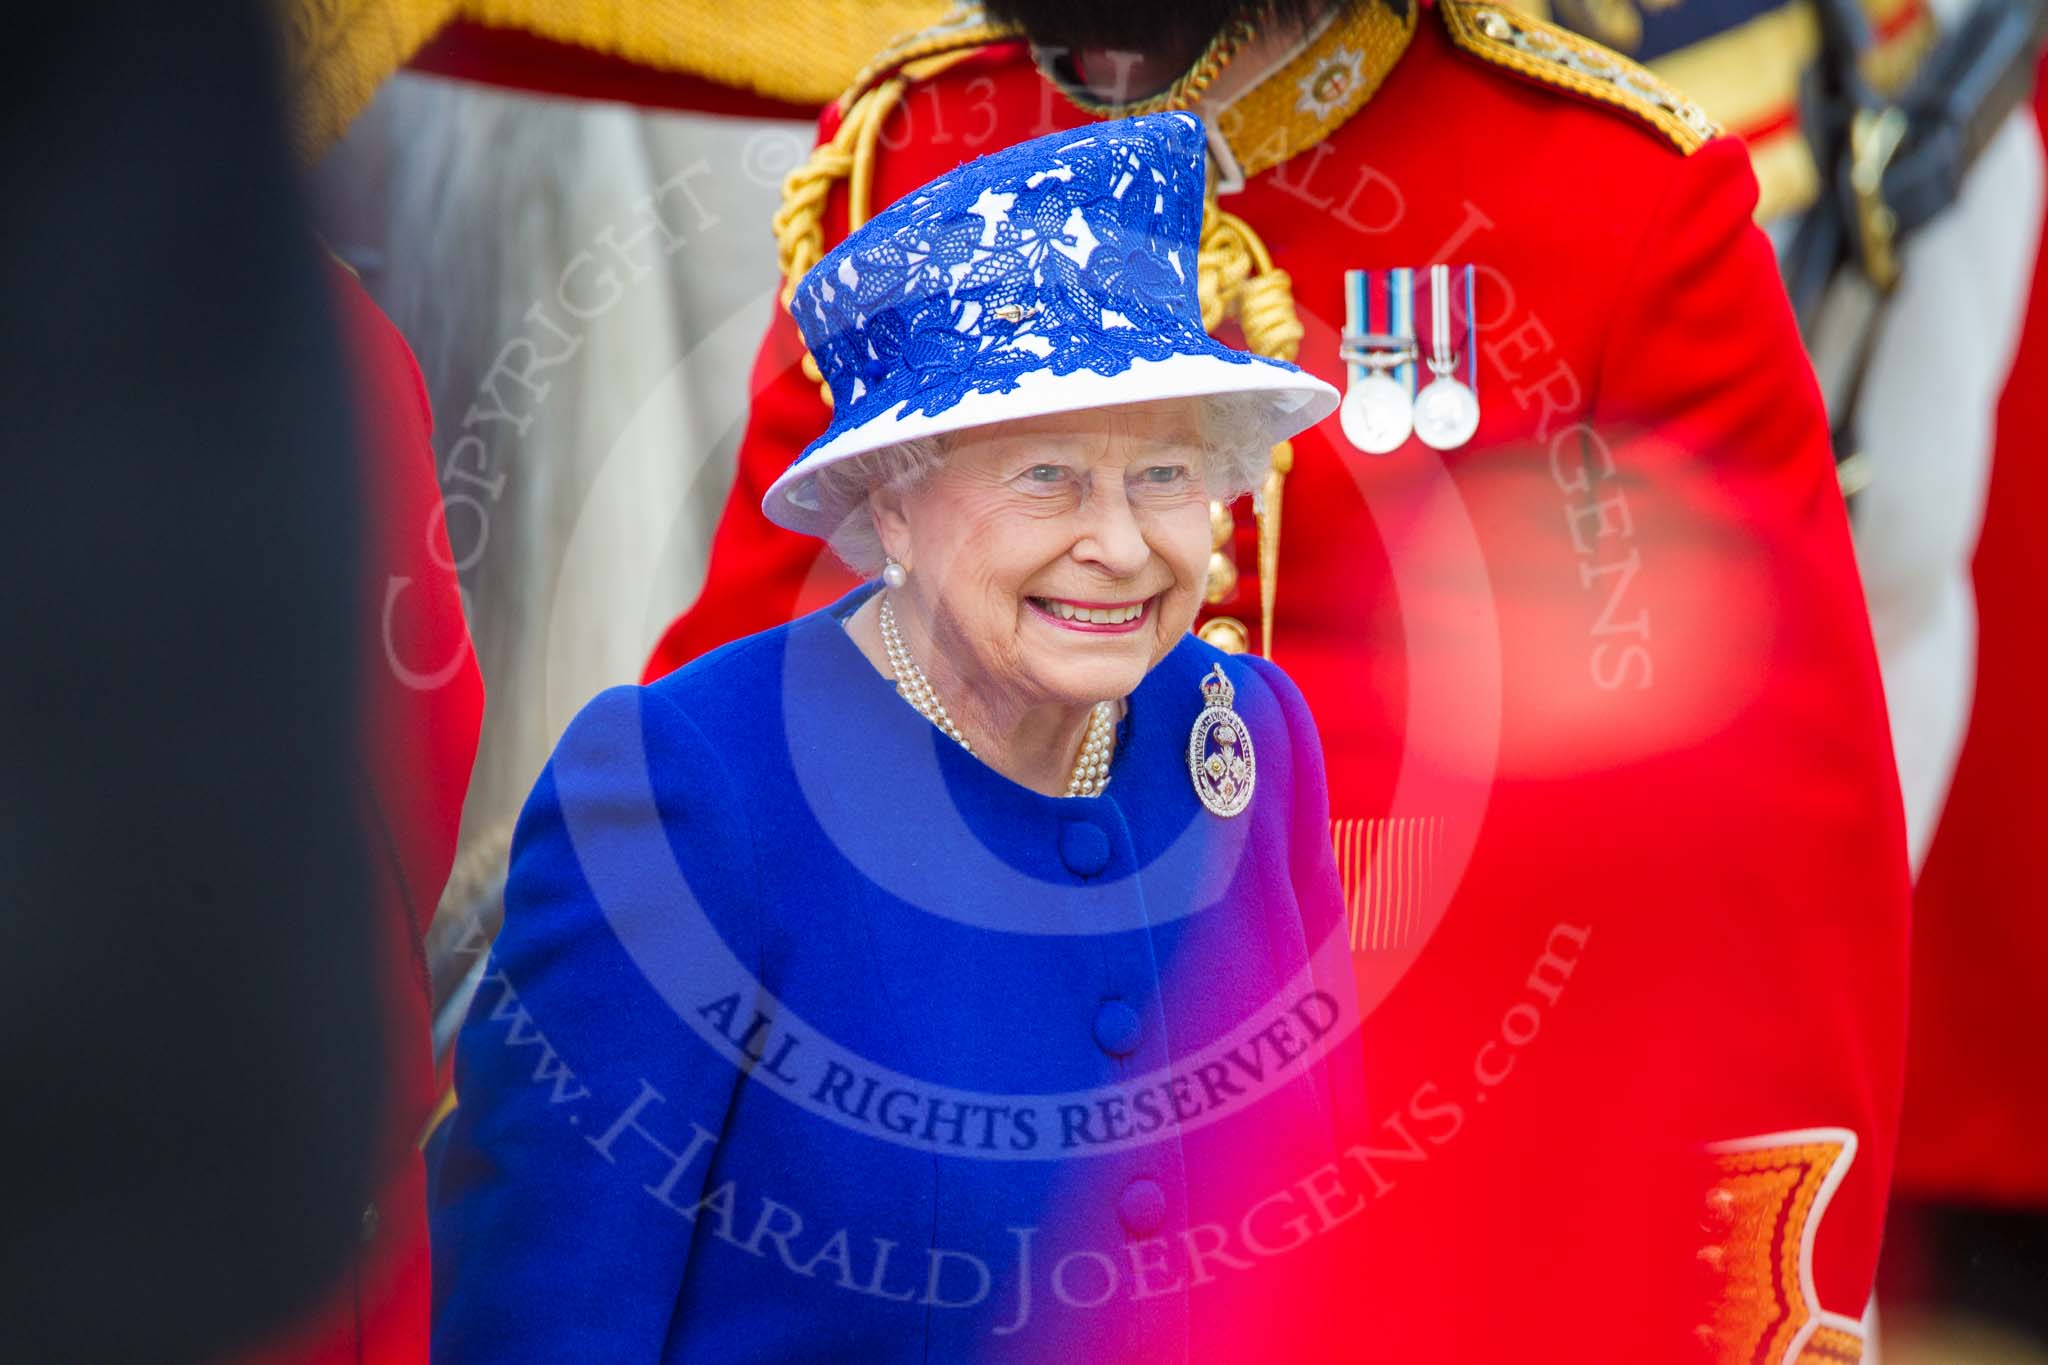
<box><xmin>813</xmin><ymin>393</ymin><xmax>1272</xmax><ymax>579</ymax></box>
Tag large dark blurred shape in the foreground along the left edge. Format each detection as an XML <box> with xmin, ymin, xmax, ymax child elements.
<box><xmin>0</xmin><ymin>2</ymin><xmax>381</xmax><ymax>1361</ymax></box>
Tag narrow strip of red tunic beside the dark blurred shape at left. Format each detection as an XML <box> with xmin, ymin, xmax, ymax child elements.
<box><xmin>240</xmin><ymin>264</ymin><xmax>483</xmax><ymax>1365</ymax></box>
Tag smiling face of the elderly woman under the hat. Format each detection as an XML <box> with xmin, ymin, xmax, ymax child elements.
<box><xmin>872</xmin><ymin>401</ymin><xmax>1210</xmax><ymax>706</ymax></box>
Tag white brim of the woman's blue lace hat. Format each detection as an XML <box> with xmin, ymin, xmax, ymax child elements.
<box><xmin>762</xmin><ymin>352</ymin><xmax>1339</xmax><ymax>538</ymax></box>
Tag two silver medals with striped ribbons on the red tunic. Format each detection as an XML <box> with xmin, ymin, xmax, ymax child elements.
<box><xmin>1337</xmin><ymin>266</ymin><xmax>1479</xmax><ymax>454</ymax></box>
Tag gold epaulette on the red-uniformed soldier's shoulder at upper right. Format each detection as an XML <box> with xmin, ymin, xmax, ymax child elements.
<box><xmin>1436</xmin><ymin>0</ymin><xmax>1720</xmax><ymax>156</ymax></box>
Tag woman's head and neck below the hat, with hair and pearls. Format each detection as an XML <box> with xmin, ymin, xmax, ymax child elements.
<box><xmin>817</xmin><ymin>399</ymin><xmax>1266</xmax><ymax>796</ymax></box>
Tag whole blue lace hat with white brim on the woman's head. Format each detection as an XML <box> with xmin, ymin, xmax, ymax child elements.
<box><xmin>762</xmin><ymin>113</ymin><xmax>1337</xmax><ymax>536</ymax></box>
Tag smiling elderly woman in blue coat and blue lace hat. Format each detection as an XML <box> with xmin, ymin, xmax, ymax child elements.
<box><xmin>432</xmin><ymin>115</ymin><xmax>1362</xmax><ymax>1363</ymax></box>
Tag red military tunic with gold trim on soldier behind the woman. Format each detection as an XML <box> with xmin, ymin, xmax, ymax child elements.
<box><xmin>649</xmin><ymin>0</ymin><xmax>1909</xmax><ymax>1361</ymax></box>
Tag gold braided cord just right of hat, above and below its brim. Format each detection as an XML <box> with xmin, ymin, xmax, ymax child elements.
<box><xmin>1196</xmin><ymin>188</ymin><xmax>1303</xmax><ymax>659</ymax></box>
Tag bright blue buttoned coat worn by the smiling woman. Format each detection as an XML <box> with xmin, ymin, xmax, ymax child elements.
<box><xmin>432</xmin><ymin>589</ymin><xmax>1360</xmax><ymax>1365</ymax></box>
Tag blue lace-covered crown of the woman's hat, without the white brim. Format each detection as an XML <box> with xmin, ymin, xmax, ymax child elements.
<box><xmin>791</xmin><ymin>113</ymin><xmax>1251</xmax><ymax>444</ymax></box>
